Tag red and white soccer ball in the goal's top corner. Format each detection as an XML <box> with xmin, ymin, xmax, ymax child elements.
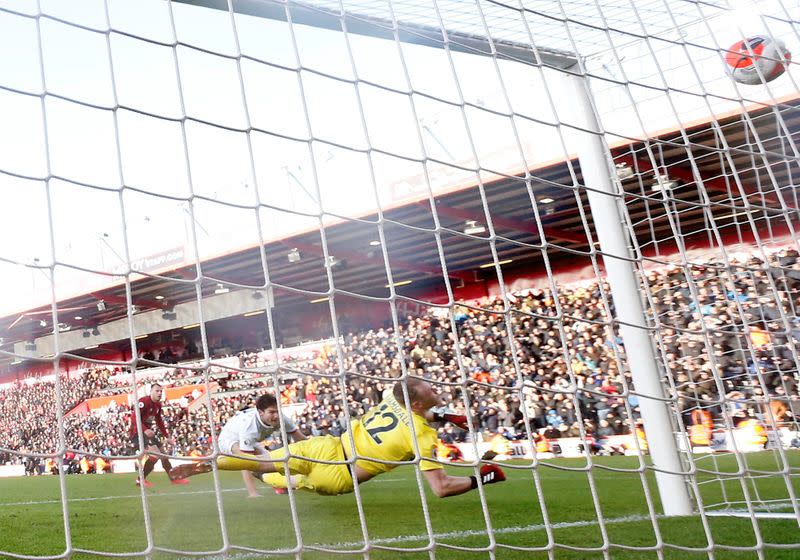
<box><xmin>725</xmin><ymin>35</ymin><xmax>792</xmax><ymax>85</ymax></box>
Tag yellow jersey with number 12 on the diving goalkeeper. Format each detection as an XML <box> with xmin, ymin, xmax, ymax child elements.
<box><xmin>342</xmin><ymin>393</ymin><xmax>443</xmax><ymax>475</ymax></box>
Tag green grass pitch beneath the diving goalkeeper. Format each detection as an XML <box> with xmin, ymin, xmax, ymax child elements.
<box><xmin>0</xmin><ymin>452</ymin><xmax>800</xmax><ymax>560</ymax></box>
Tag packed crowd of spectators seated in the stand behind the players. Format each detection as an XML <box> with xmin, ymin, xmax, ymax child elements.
<box><xmin>0</xmin><ymin>250</ymin><xmax>800</xmax><ymax>461</ymax></box>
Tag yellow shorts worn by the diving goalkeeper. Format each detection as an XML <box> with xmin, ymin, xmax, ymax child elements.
<box><xmin>261</xmin><ymin>436</ymin><xmax>353</xmax><ymax>496</ymax></box>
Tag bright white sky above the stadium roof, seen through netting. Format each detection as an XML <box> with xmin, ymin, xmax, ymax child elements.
<box><xmin>0</xmin><ymin>0</ymin><xmax>800</xmax><ymax>315</ymax></box>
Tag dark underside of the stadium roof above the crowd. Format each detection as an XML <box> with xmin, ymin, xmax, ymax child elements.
<box><xmin>0</xmin><ymin>94</ymin><xmax>800</xmax><ymax>366</ymax></box>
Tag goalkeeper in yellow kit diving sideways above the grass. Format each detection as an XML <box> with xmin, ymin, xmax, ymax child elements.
<box><xmin>170</xmin><ymin>378</ymin><xmax>506</xmax><ymax>498</ymax></box>
